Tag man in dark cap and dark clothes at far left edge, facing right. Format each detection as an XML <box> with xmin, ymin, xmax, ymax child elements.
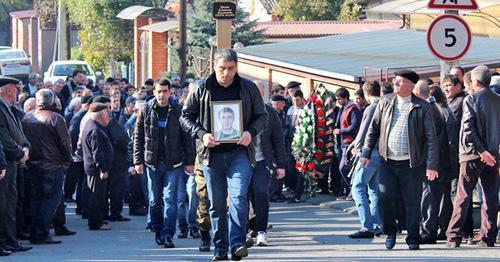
<box><xmin>0</xmin><ymin>77</ymin><xmax>31</xmax><ymax>254</ymax></box>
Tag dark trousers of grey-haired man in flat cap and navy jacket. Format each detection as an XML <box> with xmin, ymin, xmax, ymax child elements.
<box><xmin>87</xmin><ymin>174</ymin><xmax>107</xmax><ymax>230</ymax></box>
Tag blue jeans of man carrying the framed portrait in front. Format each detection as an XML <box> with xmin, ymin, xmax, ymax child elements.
<box><xmin>202</xmin><ymin>149</ymin><xmax>252</xmax><ymax>252</ymax></box>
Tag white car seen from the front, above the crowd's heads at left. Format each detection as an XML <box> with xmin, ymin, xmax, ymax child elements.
<box><xmin>43</xmin><ymin>60</ymin><xmax>96</xmax><ymax>83</ymax></box>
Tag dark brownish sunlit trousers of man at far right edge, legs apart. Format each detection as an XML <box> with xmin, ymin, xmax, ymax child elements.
<box><xmin>446</xmin><ymin>159</ymin><xmax>499</xmax><ymax>244</ymax></box>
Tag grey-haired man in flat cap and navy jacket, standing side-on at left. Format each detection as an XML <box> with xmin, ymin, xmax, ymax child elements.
<box><xmin>82</xmin><ymin>102</ymin><xmax>113</xmax><ymax>230</ymax></box>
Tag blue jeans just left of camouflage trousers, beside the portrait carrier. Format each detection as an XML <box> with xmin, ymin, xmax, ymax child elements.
<box><xmin>177</xmin><ymin>173</ymin><xmax>199</xmax><ymax>232</ymax></box>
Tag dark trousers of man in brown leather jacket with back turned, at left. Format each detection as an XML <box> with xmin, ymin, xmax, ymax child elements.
<box><xmin>31</xmin><ymin>169</ymin><xmax>64</xmax><ymax>241</ymax></box>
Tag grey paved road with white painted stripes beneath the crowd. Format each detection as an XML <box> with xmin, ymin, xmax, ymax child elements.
<box><xmin>5</xmin><ymin>200</ymin><xmax>500</xmax><ymax>262</ymax></box>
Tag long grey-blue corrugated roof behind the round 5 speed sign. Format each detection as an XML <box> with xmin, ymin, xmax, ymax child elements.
<box><xmin>237</xmin><ymin>29</ymin><xmax>500</xmax><ymax>82</ymax></box>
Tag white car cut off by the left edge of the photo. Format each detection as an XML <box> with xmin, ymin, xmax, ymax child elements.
<box><xmin>0</xmin><ymin>47</ymin><xmax>33</xmax><ymax>82</ymax></box>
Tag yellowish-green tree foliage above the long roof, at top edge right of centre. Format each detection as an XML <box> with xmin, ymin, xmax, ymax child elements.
<box><xmin>276</xmin><ymin>0</ymin><xmax>342</xmax><ymax>21</ymax></box>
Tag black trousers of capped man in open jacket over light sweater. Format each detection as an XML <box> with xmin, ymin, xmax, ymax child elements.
<box><xmin>379</xmin><ymin>160</ymin><xmax>425</xmax><ymax>244</ymax></box>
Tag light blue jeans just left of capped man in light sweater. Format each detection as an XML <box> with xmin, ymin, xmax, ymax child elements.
<box><xmin>352</xmin><ymin>149</ymin><xmax>381</xmax><ymax>231</ymax></box>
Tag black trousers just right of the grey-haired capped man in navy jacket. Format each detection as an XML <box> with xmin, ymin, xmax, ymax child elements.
<box><xmin>104</xmin><ymin>169</ymin><xmax>127</xmax><ymax>218</ymax></box>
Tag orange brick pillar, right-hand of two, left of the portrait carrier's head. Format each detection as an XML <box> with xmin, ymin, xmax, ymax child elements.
<box><xmin>148</xmin><ymin>32</ymin><xmax>168</xmax><ymax>80</ymax></box>
